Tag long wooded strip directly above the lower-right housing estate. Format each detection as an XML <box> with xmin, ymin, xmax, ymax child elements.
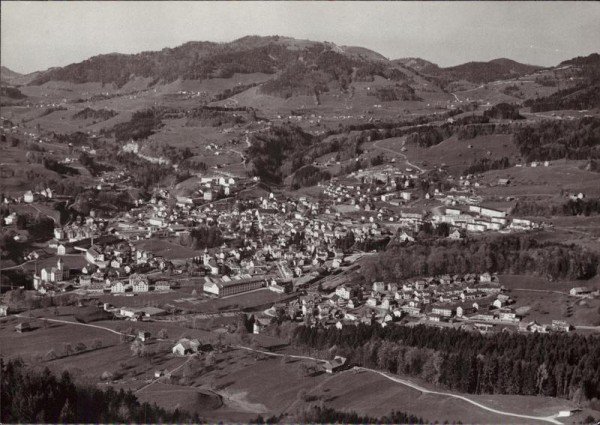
<box><xmin>361</xmin><ymin>235</ymin><xmax>599</xmax><ymax>281</ymax></box>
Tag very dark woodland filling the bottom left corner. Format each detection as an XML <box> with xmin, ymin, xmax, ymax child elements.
<box><xmin>0</xmin><ymin>359</ymin><xmax>200</xmax><ymax>423</ymax></box>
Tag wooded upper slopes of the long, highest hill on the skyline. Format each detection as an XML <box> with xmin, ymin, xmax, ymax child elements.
<box><xmin>25</xmin><ymin>36</ymin><xmax>539</xmax><ymax>97</ymax></box>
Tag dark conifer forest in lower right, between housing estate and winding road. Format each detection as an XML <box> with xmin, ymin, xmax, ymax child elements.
<box><xmin>292</xmin><ymin>324</ymin><xmax>600</xmax><ymax>402</ymax></box>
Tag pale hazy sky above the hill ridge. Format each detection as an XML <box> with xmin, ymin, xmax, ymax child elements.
<box><xmin>0</xmin><ymin>0</ymin><xmax>600</xmax><ymax>73</ymax></box>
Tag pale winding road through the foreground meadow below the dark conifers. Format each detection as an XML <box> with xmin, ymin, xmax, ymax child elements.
<box><xmin>232</xmin><ymin>345</ymin><xmax>562</xmax><ymax>425</ymax></box>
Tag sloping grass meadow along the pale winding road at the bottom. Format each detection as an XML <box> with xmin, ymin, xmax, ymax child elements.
<box><xmin>137</xmin><ymin>346</ymin><xmax>570</xmax><ymax>423</ymax></box>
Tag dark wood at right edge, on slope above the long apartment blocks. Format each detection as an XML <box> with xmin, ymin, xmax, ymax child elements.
<box><xmin>513</xmin><ymin>117</ymin><xmax>600</xmax><ymax>161</ymax></box>
